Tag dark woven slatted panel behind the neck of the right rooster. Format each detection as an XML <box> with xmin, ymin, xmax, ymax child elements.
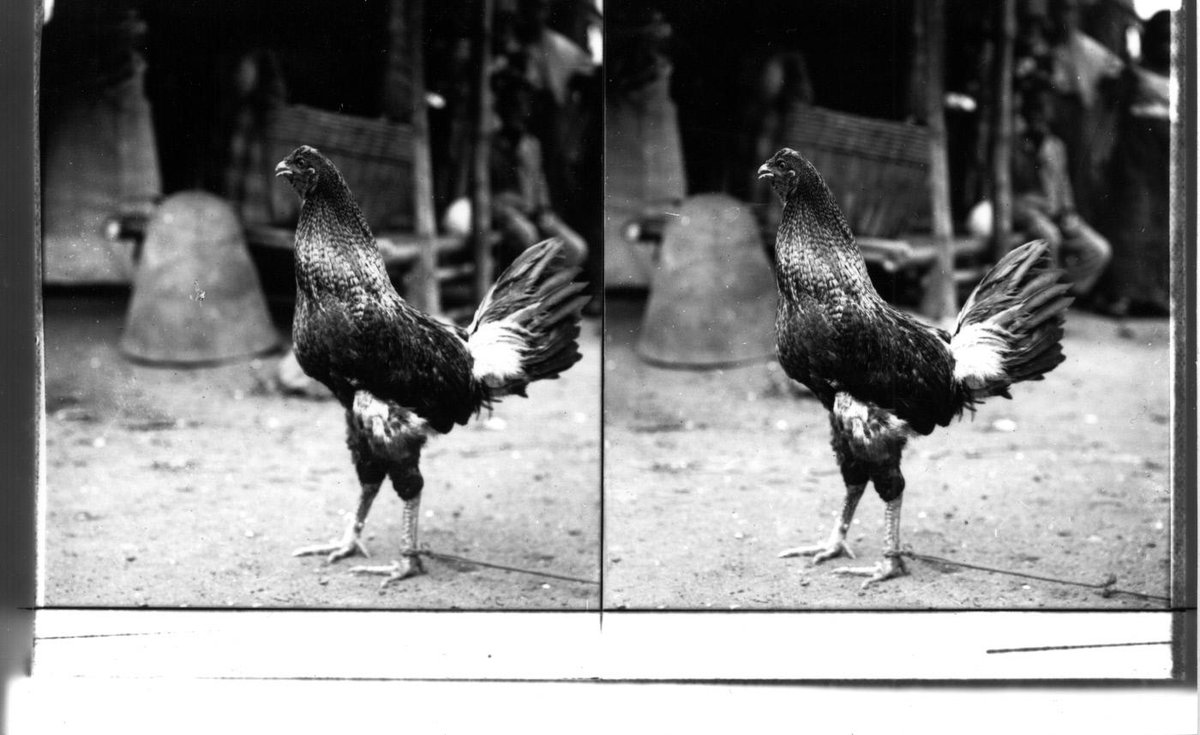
<box><xmin>782</xmin><ymin>106</ymin><xmax>929</xmax><ymax>238</ymax></box>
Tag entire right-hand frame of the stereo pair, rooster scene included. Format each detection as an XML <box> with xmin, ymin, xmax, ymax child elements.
<box><xmin>605</xmin><ymin>1</ymin><xmax>1174</xmax><ymax>610</ymax></box>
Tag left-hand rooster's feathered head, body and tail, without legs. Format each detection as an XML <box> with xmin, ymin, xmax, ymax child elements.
<box><xmin>281</xmin><ymin>147</ymin><xmax>587</xmax><ymax>432</ymax></box>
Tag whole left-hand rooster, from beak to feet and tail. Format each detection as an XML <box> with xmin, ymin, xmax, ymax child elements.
<box><xmin>275</xmin><ymin>145</ymin><xmax>588</xmax><ymax>586</ymax></box>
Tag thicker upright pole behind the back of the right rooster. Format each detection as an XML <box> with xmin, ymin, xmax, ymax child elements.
<box><xmin>917</xmin><ymin>0</ymin><xmax>958</xmax><ymax>321</ymax></box>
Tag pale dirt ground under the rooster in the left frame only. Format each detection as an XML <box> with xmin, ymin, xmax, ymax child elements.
<box><xmin>42</xmin><ymin>293</ymin><xmax>600</xmax><ymax>610</ymax></box>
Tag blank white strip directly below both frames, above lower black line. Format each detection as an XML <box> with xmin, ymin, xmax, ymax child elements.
<box><xmin>34</xmin><ymin>610</ymin><xmax>1171</xmax><ymax>681</ymax></box>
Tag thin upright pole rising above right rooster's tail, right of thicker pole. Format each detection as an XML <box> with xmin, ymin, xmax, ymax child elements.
<box><xmin>991</xmin><ymin>0</ymin><xmax>1016</xmax><ymax>259</ymax></box>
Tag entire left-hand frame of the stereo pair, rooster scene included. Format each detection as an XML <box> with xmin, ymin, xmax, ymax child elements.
<box><xmin>41</xmin><ymin>0</ymin><xmax>601</xmax><ymax>610</ymax></box>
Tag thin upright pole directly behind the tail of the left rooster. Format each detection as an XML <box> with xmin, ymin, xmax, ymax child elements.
<box><xmin>470</xmin><ymin>0</ymin><xmax>493</xmax><ymax>300</ymax></box>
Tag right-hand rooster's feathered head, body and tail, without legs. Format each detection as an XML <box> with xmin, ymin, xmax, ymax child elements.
<box><xmin>763</xmin><ymin>149</ymin><xmax>1070</xmax><ymax>434</ymax></box>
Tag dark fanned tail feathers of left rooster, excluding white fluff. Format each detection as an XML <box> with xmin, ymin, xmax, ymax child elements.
<box><xmin>468</xmin><ymin>239</ymin><xmax>590</xmax><ymax>394</ymax></box>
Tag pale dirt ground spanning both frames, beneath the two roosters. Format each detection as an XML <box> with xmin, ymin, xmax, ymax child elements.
<box><xmin>32</xmin><ymin>289</ymin><xmax>1170</xmax><ymax>609</ymax></box>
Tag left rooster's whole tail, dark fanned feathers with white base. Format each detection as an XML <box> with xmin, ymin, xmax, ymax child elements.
<box><xmin>467</xmin><ymin>240</ymin><xmax>589</xmax><ymax>395</ymax></box>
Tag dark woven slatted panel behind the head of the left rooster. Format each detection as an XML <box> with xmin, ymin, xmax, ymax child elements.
<box><xmin>266</xmin><ymin>104</ymin><xmax>413</xmax><ymax>232</ymax></box>
